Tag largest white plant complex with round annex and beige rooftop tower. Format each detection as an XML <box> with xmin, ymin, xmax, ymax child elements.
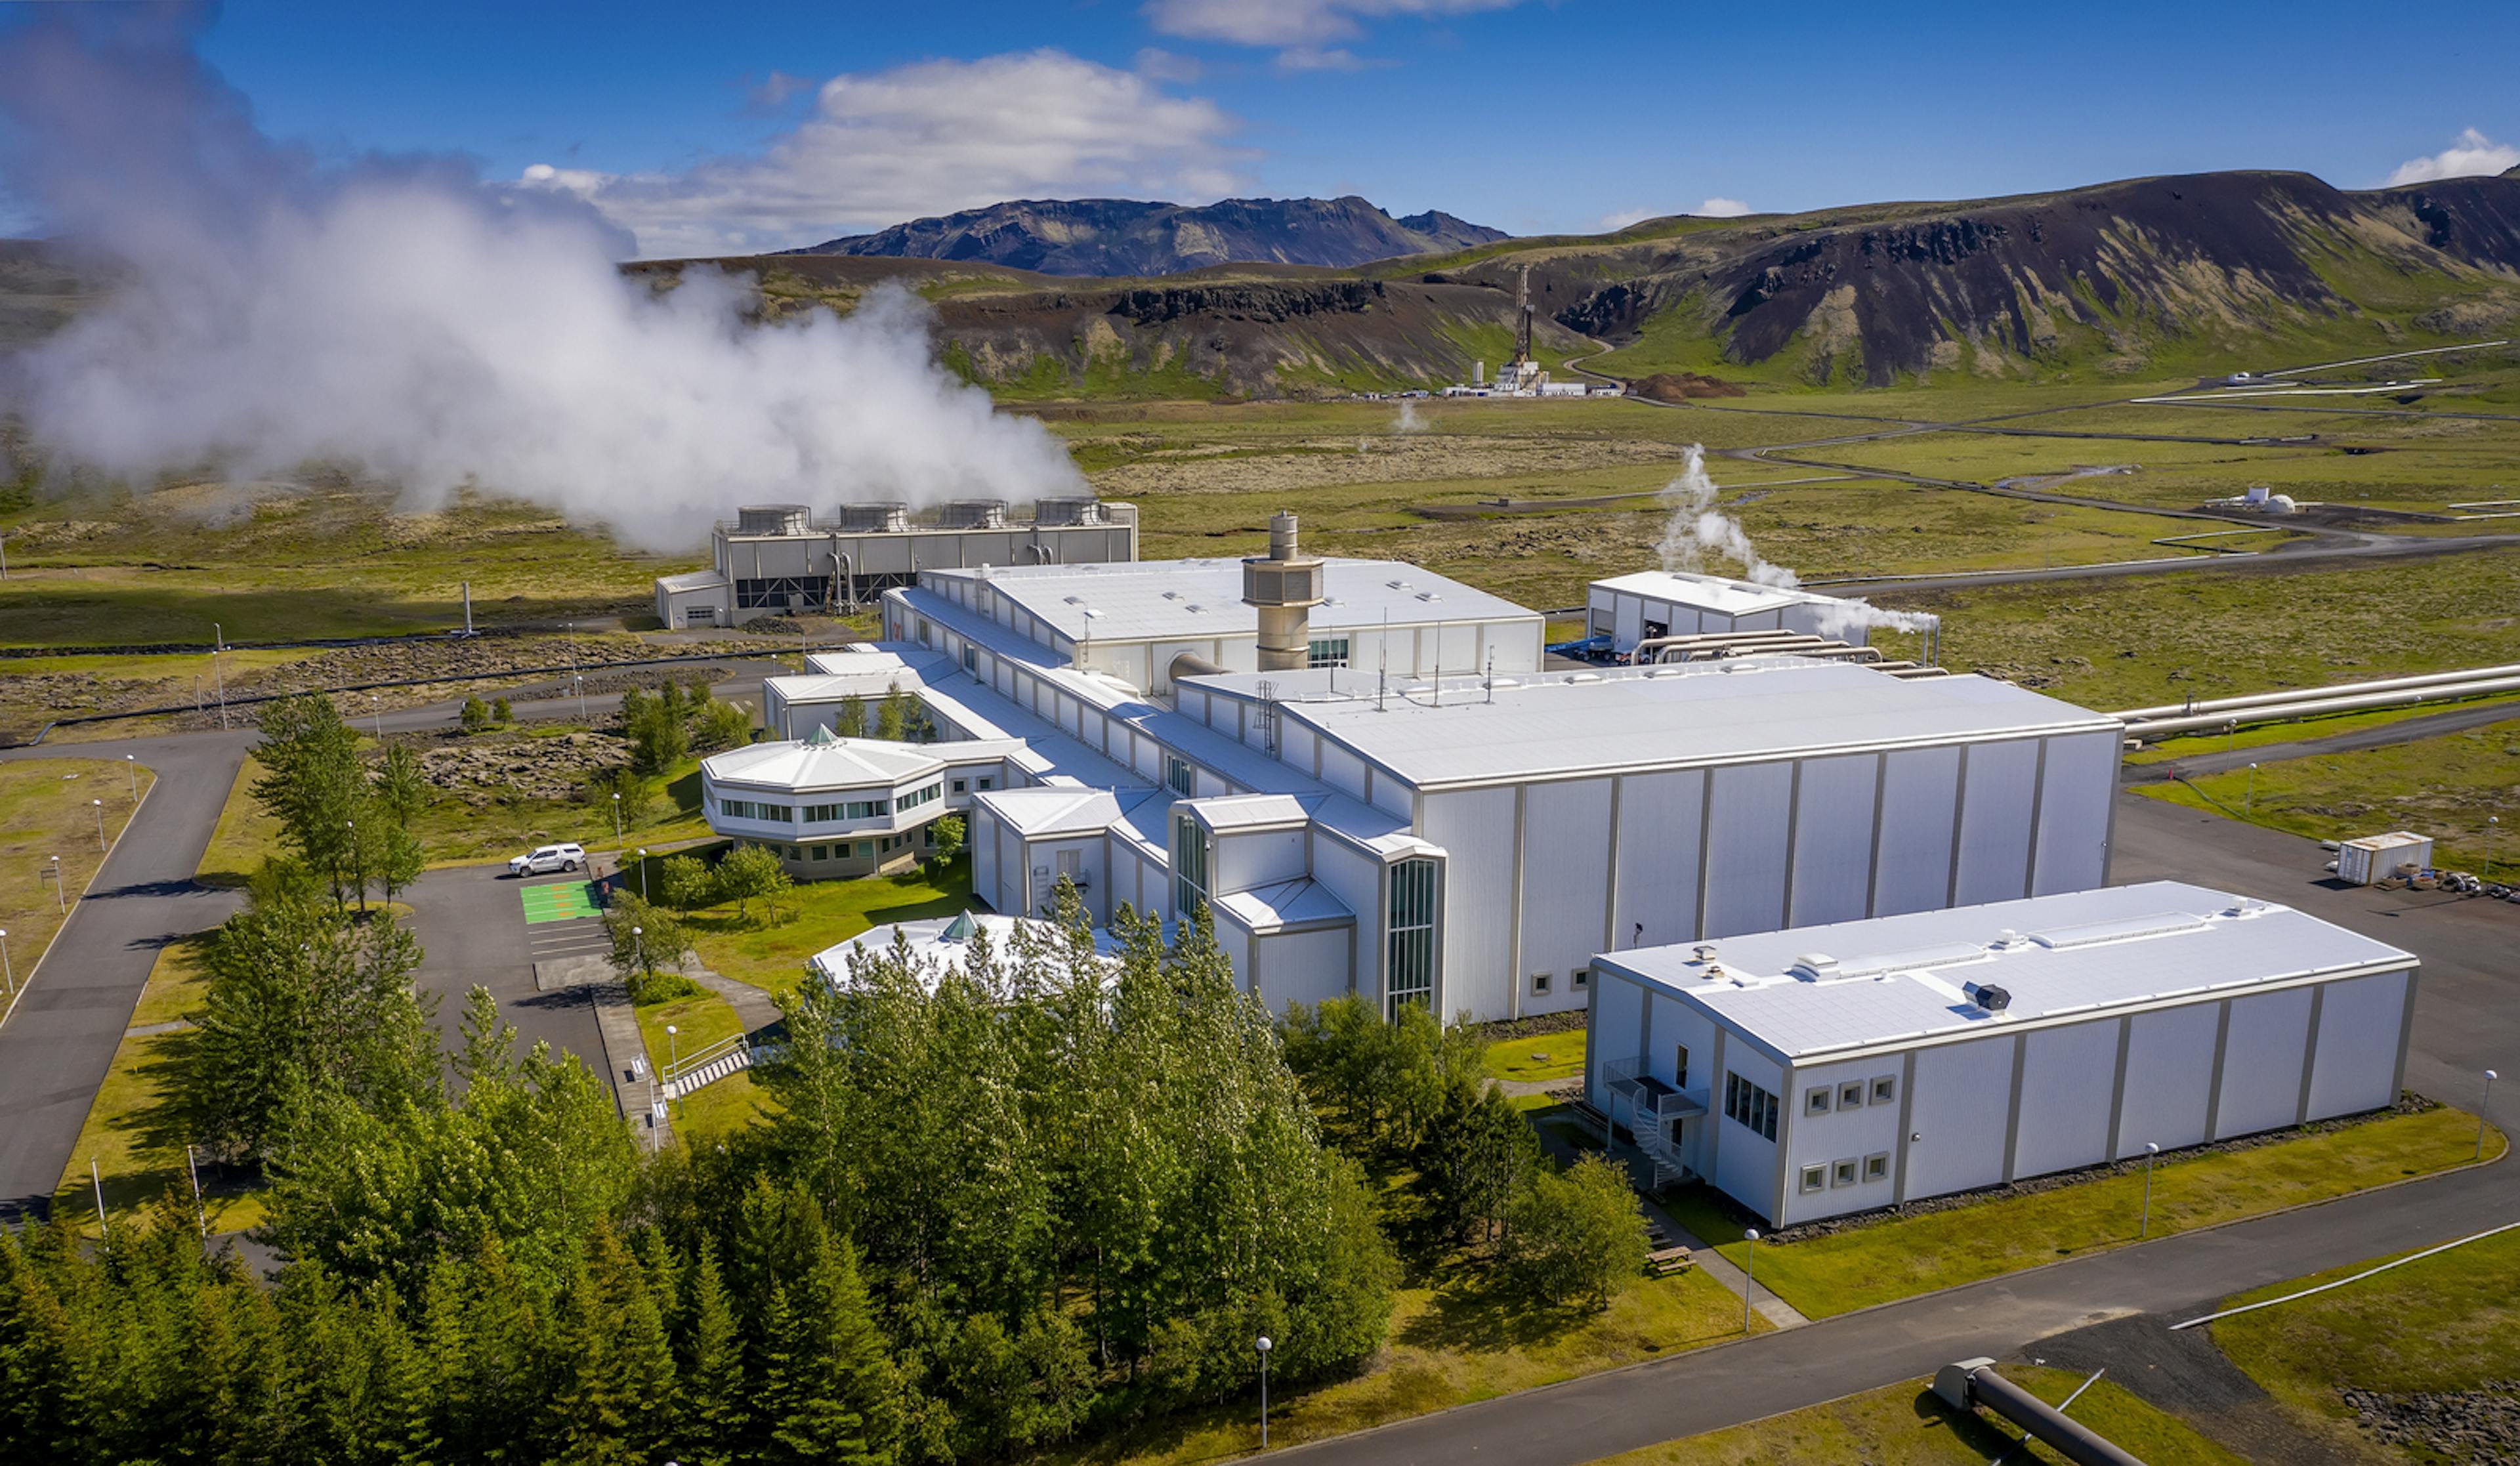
<box><xmin>703</xmin><ymin>516</ymin><xmax>2119</xmax><ymax>1018</ymax></box>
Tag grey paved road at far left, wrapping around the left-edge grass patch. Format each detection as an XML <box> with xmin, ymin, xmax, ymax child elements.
<box><xmin>0</xmin><ymin>733</ymin><xmax>252</xmax><ymax>1217</ymax></box>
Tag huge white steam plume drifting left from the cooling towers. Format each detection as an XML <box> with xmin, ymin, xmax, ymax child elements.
<box><xmin>0</xmin><ymin>8</ymin><xmax>1083</xmax><ymax>547</ymax></box>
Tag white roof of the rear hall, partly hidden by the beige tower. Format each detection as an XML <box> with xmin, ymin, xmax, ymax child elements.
<box><xmin>920</xmin><ymin>559</ymin><xmax>1540</xmax><ymax>642</ymax></box>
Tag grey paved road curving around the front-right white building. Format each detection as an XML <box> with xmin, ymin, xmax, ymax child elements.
<box><xmin>1290</xmin><ymin>793</ymin><xmax>2520</xmax><ymax>1466</ymax></box>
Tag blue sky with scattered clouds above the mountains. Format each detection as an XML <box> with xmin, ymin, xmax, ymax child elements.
<box><xmin>20</xmin><ymin>0</ymin><xmax>2520</xmax><ymax>255</ymax></box>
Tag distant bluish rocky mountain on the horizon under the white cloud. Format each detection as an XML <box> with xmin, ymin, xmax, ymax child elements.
<box><xmin>791</xmin><ymin>196</ymin><xmax>1507</xmax><ymax>277</ymax></box>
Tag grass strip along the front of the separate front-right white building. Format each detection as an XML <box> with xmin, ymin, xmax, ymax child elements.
<box><xmin>1668</xmin><ymin>1106</ymin><xmax>2505</xmax><ymax>1318</ymax></box>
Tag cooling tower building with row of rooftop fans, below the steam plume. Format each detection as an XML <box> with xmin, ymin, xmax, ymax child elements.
<box><xmin>655</xmin><ymin>496</ymin><xmax>1137</xmax><ymax>630</ymax></box>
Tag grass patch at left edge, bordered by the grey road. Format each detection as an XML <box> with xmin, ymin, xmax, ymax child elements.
<box><xmin>0</xmin><ymin>758</ymin><xmax>156</xmax><ymax>1010</ymax></box>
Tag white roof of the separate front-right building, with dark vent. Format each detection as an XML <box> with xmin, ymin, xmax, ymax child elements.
<box><xmin>1595</xmin><ymin>881</ymin><xmax>2417</xmax><ymax>1060</ymax></box>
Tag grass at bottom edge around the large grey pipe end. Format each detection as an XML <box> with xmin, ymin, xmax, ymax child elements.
<box><xmin>1593</xmin><ymin>1365</ymin><xmax>2243</xmax><ymax>1466</ymax></box>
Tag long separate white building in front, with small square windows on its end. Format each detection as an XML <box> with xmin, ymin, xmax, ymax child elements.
<box><xmin>1585</xmin><ymin>881</ymin><xmax>2417</xmax><ymax>1226</ymax></box>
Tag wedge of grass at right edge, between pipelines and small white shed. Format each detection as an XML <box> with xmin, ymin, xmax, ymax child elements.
<box><xmin>2137</xmin><ymin>718</ymin><xmax>2520</xmax><ymax>877</ymax></box>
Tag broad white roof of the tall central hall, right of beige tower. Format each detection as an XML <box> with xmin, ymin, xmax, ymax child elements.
<box><xmin>1194</xmin><ymin>658</ymin><xmax>2119</xmax><ymax>788</ymax></box>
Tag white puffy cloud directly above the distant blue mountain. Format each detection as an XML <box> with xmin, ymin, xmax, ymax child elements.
<box><xmin>522</xmin><ymin>51</ymin><xmax>1250</xmax><ymax>257</ymax></box>
